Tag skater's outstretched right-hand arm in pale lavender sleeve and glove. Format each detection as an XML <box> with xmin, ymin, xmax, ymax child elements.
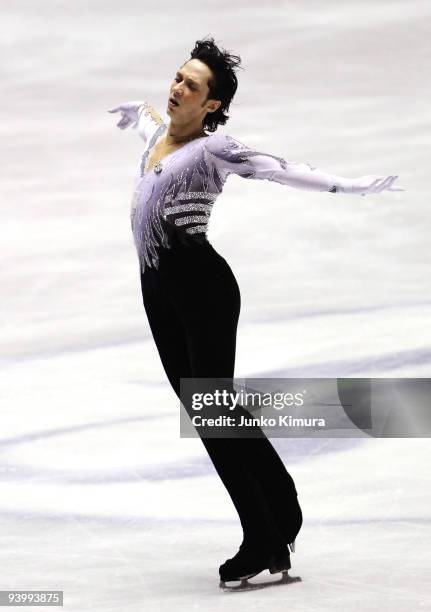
<box><xmin>207</xmin><ymin>134</ymin><xmax>405</xmax><ymax>195</ymax></box>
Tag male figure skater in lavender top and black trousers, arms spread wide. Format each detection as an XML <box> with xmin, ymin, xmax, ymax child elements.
<box><xmin>109</xmin><ymin>38</ymin><xmax>404</xmax><ymax>586</ymax></box>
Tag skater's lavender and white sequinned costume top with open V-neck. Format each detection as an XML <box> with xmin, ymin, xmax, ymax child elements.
<box><xmin>131</xmin><ymin>102</ymin><xmax>351</xmax><ymax>272</ymax></box>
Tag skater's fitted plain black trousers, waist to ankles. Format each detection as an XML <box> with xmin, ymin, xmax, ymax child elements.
<box><xmin>141</xmin><ymin>221</ymin><xmax>302</xmax><ymax>549</ymax></box>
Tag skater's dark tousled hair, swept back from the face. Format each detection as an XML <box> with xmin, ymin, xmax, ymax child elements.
<box><xmin>185</xmin><ymin>37</ymin><xmax>242</xmax><ymax>132</ymax></box>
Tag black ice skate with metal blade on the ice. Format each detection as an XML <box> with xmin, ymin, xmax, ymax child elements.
<box><xmin>219</xmin><ymin>544</ymin><xmax>301</xmax><ymax>591</ymax></box>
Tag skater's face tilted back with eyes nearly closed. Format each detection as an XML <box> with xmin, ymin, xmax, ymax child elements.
<box><xmin>167</xmin><ymin>59</ymin><xmax>221</xmax><ymax>122</ymax></box>
